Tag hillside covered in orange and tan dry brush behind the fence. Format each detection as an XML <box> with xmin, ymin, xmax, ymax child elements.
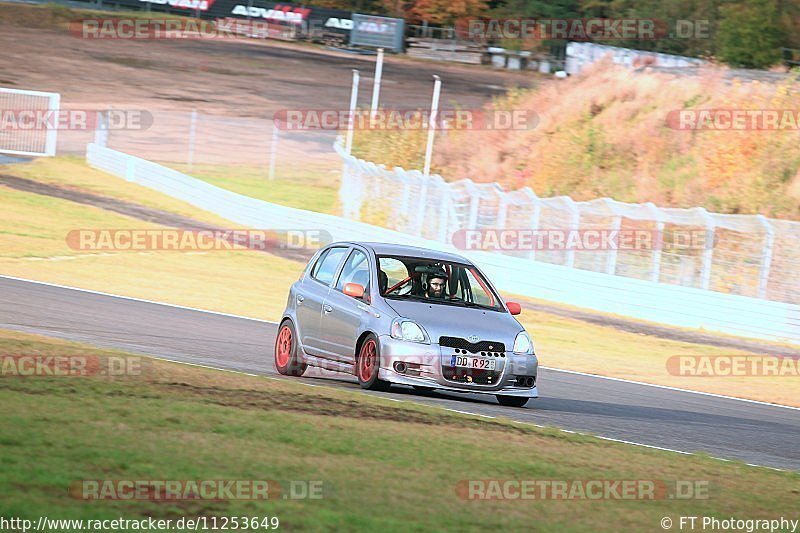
<box><xmin>356</xmin><ymin>63</ymin><xmax>800</xmax><ymax>219</ymax></box>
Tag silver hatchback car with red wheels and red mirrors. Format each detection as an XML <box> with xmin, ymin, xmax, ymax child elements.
<box><xmin>275</xmin><ymin>242</ymin><xmax>539</xmax><ymax>407</ymax></box>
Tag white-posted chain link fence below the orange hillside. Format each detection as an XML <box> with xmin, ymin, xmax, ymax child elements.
<box><xmin>336</xmin><ymin>144</ymin><xmax>800</xmax><ymax>304</ymax></box>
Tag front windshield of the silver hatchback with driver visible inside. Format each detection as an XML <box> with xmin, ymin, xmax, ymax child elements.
<box><xmin>378</xmin><ymin>256</ymin><xmax>502</xmax><ymax>311</ymax></box>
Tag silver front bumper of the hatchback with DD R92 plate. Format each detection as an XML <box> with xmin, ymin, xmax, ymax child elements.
<box><xmin>378</xmin><ymin>335</ymin><xmax>539</xmax><ymax>398</ymax></box>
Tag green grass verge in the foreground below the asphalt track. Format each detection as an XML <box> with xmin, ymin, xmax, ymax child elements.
<box><xmin>0</xmin><ymin>330</ymin><xmax>800</xmax><ymax>531</ymax></box>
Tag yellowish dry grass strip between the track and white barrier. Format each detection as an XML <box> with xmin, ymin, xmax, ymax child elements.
<box><xmin>0</xmin><ymin>158</ymin><xmax>800</xmax><ymax>406</ymax></box>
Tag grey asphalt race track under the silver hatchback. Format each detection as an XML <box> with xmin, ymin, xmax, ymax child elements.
<box><xmin>0</xmin><ymin>277</ymin><xmax>800</xmax><ymax>470</ymax></box>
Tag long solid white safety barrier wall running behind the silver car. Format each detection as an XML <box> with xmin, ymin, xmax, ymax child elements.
<box><xmin>86</xmin><ymin>143</ymin><xmax>800</xmax><ymax>344</ymax></box>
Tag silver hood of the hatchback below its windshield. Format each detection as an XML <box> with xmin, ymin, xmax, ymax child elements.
<box><xmin>385</xmin><ymin>299</ymin><xmax>522</xmax><ymax>342</ymax></box>
